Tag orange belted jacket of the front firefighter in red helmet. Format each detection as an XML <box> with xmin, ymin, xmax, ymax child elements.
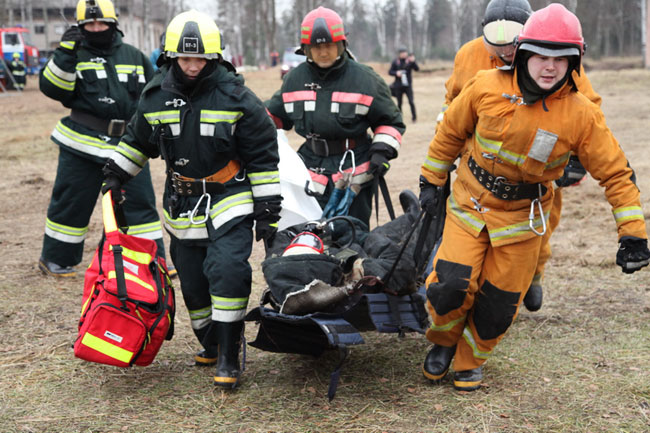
<box><xmin>422</xmin><ymin>69</ymin><xmax>647</xmax><ymax>246</ymax></box>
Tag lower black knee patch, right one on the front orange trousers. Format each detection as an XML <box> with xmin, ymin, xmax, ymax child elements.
<box><xmin>474</xmin><ymin>280</ymin><xmax>519</xmax><ymax>340</ymax></box>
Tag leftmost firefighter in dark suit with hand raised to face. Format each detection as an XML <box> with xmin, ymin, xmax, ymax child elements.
<box><xmin>39</xmin><ymin>0</ymin><xmax>165</xmax><ymax>277</ymax></box>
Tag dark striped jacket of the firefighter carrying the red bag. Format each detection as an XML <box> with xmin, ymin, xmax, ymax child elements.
<box><xmin>109</xmin><ymin>65</ymin><xmax>280</xmax><ymax>240</ymax></box>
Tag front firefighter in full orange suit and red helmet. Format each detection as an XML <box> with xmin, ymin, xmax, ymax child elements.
<box><xmin>420</xmin><ymin>3</ymin><xmax>650</xmax><ymax>391</ymax></box>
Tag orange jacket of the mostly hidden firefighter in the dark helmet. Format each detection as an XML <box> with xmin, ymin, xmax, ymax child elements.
<box><xmin>439</xmin><ymin>36</ymin><xmax>602</xmax><ymax>112</ymax></box>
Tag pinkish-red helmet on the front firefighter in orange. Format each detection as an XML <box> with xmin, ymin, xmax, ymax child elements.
<box><xmin>515</xmin><ymin>3</ymin><xmax>585</xmax><ymax>57</ymax></box>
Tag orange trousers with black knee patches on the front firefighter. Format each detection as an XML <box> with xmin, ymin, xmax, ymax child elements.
<box><xmin>426</xmin><ymin>218</ymin><xmax>542</xmax><ymax>371</ymax></box>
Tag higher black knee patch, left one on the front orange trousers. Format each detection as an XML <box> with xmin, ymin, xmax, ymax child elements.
<box><xmin>427</xmin><ymin>259</ymin><xmax>472</xmax><ymax>316</ymax></box>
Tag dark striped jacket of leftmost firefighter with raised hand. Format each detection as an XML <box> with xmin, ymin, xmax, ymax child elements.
<box><xmin>39</xmin><ymin>33</ymin><xmax>153</xmax><ymax>163</ymax></box>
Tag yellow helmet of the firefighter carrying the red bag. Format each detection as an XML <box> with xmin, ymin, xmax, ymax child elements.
<box><xmin>164</xmin><ymin>9</ymin><xmax>221</xmax><ymax>59</ymax></box>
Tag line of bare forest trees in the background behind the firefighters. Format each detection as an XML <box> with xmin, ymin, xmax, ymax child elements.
<box><xmin>0</xmin><ymin>0</ymin><xmax>646</xmax><ymax>64</ymax></box>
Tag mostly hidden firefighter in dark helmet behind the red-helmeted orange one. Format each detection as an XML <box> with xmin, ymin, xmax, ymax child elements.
<box><xmin>438</xmin><ymin>0</ymin><xmax>601</xmax><ymax>311</ymax></box>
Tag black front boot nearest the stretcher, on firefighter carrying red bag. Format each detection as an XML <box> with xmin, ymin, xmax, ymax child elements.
<box><xmin>212</xmin><ymin>320</ymin><xmax>244</xmax><ymax>389</ymax></box>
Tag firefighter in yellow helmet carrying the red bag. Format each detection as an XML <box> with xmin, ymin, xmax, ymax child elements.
<box><xmin>104</xmin><ymin>10</ymin><xmax>282</xmax><ymax>388</ymax></box>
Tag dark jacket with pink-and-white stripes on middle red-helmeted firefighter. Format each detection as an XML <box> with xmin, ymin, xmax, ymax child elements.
<box><xmin>266</xmin><ymin>52</ymin><xmax>406</xmax><ymax>189</ymax></box>
